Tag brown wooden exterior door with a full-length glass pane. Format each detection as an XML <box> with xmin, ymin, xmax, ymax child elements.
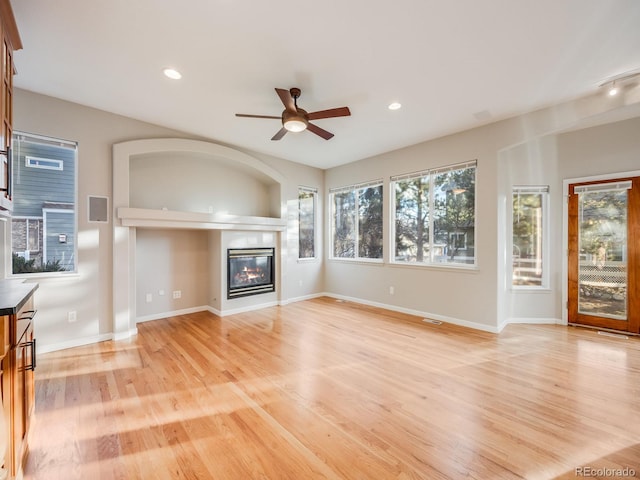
<box><xmin>568</xmin><ymin>177</ymin><xmax>640</xmax><ymax>333</ymax></box>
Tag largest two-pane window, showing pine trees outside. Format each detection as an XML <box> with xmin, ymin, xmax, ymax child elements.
<box><xmin>391</xmin><ymin>161</ymin><xmax>476</xmax><ymax>265</ymax></box>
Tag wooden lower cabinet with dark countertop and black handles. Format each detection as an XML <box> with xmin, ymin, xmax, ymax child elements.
<box><xmin>0</xmin><ymin>284</ymin><xmax>37</xmax><ymax>479</ymax></box>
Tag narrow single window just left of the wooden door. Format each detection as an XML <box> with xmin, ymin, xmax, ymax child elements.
<box><xmin>512</xmin><ymin>186</ymin><xmax>549</xmax><ymax>287</ymax></box>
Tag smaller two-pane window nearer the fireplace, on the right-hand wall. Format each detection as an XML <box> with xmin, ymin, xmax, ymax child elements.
<box><xmin>329</xmin><ymin>180</ymin><xmax>383</xmax><ymax>260</ymax></box>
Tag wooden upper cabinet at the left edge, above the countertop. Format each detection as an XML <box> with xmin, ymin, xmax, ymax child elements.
<box><xmin>0</xmin><ymin>0</ymin><xmax>22</xmax><ymax>214</ymax></box>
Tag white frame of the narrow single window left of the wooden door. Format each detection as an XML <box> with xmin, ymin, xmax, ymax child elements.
<box><xmin>508</xmin><ymin>185</ymin><xmax>550</xmax><ymax>291</ymax></box>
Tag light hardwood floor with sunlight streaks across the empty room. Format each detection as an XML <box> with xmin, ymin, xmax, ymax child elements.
<box><xmin>25</xmin><ymin>298</ymin><xmax>640</xmax><ymax>480</ymax></box>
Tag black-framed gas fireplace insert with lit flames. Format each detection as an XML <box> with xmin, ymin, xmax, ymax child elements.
<box><xmin>227</xmin><ymin>248</ymin><xmax>276</xmax><ymax>299</ymax></box>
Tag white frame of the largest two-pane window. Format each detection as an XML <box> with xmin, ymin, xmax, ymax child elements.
<box><xmin>389</xmin><ymin>160</ymin><xmax>478</xmax><ymax>270</ymax></box>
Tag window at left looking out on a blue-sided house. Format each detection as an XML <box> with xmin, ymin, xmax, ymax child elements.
<box><xmin>11</xmin><ymin>133</ymin><xmax>77</xmax><ymax>274</ymax></box>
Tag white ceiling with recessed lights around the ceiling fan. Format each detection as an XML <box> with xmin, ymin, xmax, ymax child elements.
<box><xmin>12</xmin><ymin>0</ymin><xmax>640</xmax><ymax>168</ymax></box>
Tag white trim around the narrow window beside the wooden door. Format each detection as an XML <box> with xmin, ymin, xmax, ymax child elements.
<box><xmin>508</xmin><ymin>185</ymin><xmax>551</xmax><ymax>292</ymax></box>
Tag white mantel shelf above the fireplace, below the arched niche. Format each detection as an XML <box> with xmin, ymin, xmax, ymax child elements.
<box><xmin>117</xmin><ymin>207</ymin><xmax>286</xmax><ymax>231</ymax></box>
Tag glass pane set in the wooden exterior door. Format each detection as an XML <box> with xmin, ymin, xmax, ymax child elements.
<box><xmin>578</xmin><ymin>187</ymin><xmax>628</xmax><ymax>320</ymax></box>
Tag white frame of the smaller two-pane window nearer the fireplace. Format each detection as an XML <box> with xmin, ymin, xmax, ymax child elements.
<box><xmin>328</xmin><ymin>179</ymin><xmax>385</xmax><ymax>264</ymax></box>
